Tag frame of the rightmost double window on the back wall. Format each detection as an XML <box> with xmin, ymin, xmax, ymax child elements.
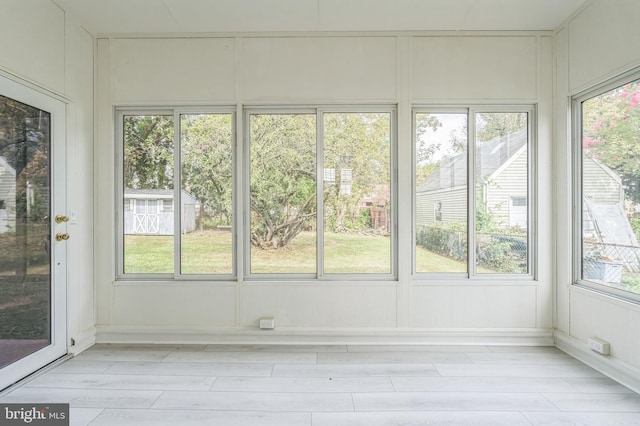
<box><xmin>412</xmin><ymin>104</ymin><xmax>538</xmax><ymax>282</ymax></box>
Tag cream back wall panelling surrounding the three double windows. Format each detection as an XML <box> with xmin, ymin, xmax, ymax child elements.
<box><xmin>95</xmin><ymin>33</ymin><xmax>553</xmax><ymax>343</ymax></box>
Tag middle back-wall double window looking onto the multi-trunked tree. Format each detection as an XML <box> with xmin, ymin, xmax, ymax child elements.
<box><xmin>247</xmin><ymin>109</ymin><xmax>393</xmax><ymax>278</ymax></box>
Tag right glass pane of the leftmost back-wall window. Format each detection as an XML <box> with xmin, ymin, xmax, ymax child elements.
<box><xmin>180</xmin><ymin>114</ymin><xmax>233</xmax><ymax>274</ymax></box>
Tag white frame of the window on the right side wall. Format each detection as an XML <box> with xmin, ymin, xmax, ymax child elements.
<box><xmin>571</xmin><ymin>69</ymin><xmax>640</xmax><ymax>304</ymax></box>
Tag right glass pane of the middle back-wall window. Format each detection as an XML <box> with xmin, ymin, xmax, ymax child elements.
<box><xmin>323</xmin><ymin>113</ymin><xmax>391</xmax><ymax>274</ymax></box>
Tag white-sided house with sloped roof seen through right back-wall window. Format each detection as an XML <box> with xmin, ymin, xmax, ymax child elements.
<box><xmin>416</xmin><ymin>129</ymin><xmax>528</xmax><ymax>228</ymax></box>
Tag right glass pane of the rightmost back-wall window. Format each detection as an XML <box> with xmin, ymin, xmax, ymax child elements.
<box><xmin>475</xmin><ymin>112</ymin><xmax>529</xmax><ymax>274</ymax></box>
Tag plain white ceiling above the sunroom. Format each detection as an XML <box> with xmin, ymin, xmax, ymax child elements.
<box><xmin>53</xmin><ymin>0</ymin><xmax>587</xmax><ymax>35</ymax></box>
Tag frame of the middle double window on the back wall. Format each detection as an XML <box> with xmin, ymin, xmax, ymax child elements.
<box><xmin>242</xmin><ymin>104</ymin><xmax>398</xmax><ymax>281</ymax></box>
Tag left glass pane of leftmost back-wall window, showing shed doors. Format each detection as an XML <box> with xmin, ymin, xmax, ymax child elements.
<box><xmin>123</xmin><ymin>115</ymin><xmax>175</xmax><ymax>274</ymax></box>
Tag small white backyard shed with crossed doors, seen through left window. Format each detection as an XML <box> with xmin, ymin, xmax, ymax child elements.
<box><xmin>124</xmin><ymin>188</ymin><xmax>199</xmax><ymax>235</ymax></box>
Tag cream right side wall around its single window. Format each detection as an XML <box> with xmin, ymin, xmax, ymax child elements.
<box><xmin>554</xmin><ymin>0</ymin><xmax>640</xmax><ymax>390</ymax></box>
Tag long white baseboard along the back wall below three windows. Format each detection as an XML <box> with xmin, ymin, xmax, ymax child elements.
<box><xmin>96</xmin><ymin>326</ymin><xmax>554</xmax><ymax>346</ymax></box>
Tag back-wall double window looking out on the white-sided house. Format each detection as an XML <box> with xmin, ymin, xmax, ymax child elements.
<box><xmin>414</xmin><ymin>107</ymin><xmax>532</xmax><ymax>277</ymax></box>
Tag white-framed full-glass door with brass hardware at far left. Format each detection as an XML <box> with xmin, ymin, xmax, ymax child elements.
<box><xmin>0</xmin><ymin>75</ymin><xmax>68</xmax><ymax>389</ymax></box>
